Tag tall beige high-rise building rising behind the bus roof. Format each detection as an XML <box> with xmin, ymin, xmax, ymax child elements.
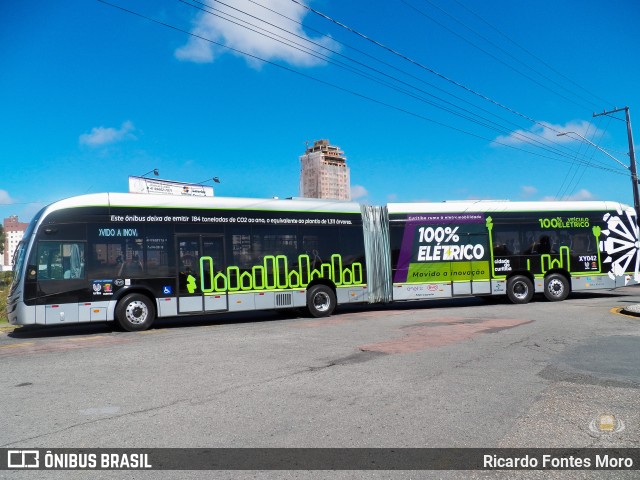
<box><xmin>300</xmin><ymin>140</ymin><xmax>351</xmax><ymax>200</ymax></box>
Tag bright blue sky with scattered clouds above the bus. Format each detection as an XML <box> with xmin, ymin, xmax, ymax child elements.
<box><xmin>0</xmin><ymin>0</ymin><xmax>640</xmax><ymax>221</ymax></box>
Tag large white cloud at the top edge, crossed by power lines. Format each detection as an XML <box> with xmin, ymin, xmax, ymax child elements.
<box><xmin>175</xmin><ymin>0</ymin><xmax>337</xmax><ymax>67</ymax></box>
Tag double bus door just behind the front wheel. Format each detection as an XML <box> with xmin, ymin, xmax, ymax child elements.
<box><xmin>177</xmin><ymin>235</ymin><xmax>228</xmax><ymax>313</ymax></box>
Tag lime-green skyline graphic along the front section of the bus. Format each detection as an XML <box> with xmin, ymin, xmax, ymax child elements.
<box><xmin>192</xmin><ymin>254</ymin><xmax>364</xmax><ymax>294</ymax></box>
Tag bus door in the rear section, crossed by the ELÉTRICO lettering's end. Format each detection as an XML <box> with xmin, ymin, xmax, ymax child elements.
<box><xmin>451</xmin><ymin>233</ymin><xmax>491</xmax><ymax>295</ymax></box>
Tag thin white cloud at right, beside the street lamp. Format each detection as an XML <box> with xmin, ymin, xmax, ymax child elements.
<box><xmin>493</xmin><ymin>120</ymin><xmax>603</xmax><ymax>146</ymax></box>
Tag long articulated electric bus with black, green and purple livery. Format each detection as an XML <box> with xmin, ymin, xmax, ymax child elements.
<box><xmin>7</xmin><ymin>193</ymin><xmax>640</xmax><ymax>331</ymax></box>
